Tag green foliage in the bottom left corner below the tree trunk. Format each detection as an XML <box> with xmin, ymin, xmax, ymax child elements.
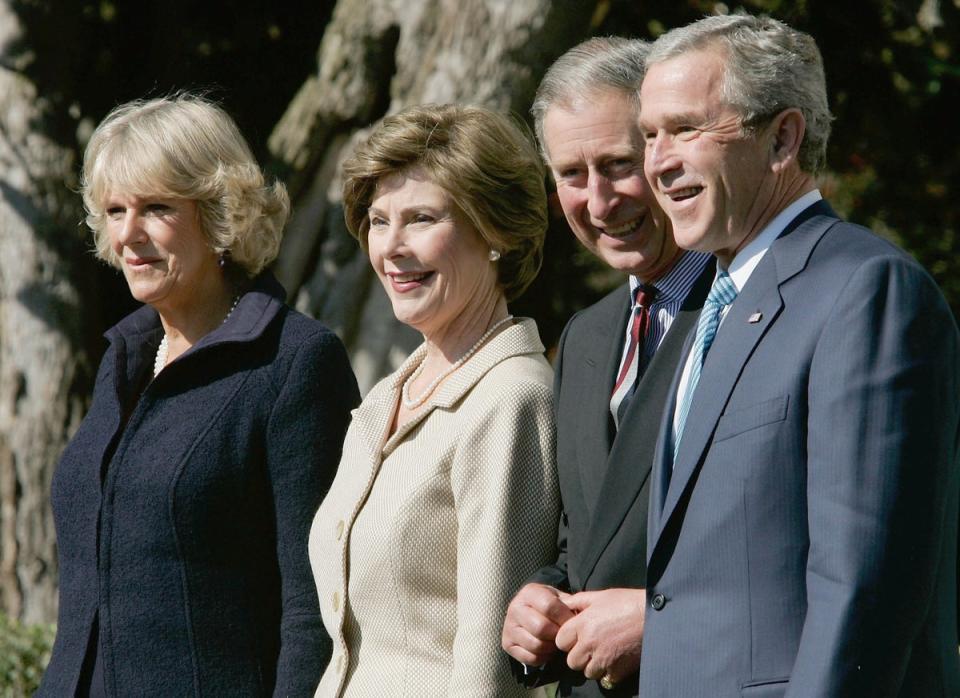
<box><xmin>0</xmin><ymin>613</ymin><xmax>54</xmax><ymax>698</ymax></box>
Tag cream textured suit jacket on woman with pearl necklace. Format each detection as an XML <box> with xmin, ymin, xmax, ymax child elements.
<box><xmin>310</xmin><ymin>319</ymin><xmax>559</xmax><ymax>698</ymax></box>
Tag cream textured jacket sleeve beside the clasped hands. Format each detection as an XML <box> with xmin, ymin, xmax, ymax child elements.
<box><xmin>449</xmin><ymin>382</ymin><xmax>559</xmax><ymax>698</ymax></box>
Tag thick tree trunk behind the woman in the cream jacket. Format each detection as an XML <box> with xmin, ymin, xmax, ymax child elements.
<box><xmin>269</xmin><ymin>0</ymin><xmax>608</xmax><ymax>392</ymax></box>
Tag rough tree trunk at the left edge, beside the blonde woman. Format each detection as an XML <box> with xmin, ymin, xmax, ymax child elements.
<box><xmin>0</xmin><ymin>0</ymin><xmax>92</xmax><ymax>622</ymax></box>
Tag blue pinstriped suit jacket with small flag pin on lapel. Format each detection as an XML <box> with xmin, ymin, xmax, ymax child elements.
<box><xmin>640</xmin><ymin>202</ymin><xmax>960</xmax><ymax>698</ymax></box>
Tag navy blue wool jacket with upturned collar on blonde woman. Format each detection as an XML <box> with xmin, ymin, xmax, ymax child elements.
<box><xmin>38</xmin><ymin>275</ymin><xmax>359</xmax><ymax>697</ymax></box>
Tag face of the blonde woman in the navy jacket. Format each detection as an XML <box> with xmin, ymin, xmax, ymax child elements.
<box><xmin>104</xmin><ymin>192</ymin><xmax>220</xmax><ymax>311</ymax></box>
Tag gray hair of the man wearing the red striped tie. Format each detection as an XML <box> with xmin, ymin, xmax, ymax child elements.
<box><xmin>530</xmin><ymin>36</ymin><xmax>650</xmax><ymax>164</ymax></box>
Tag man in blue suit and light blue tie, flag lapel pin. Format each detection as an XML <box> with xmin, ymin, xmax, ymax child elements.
<box><xmin>640</xmin><ymin>15</ymin><xmax>960</xmax><ymax>698</ymax></box>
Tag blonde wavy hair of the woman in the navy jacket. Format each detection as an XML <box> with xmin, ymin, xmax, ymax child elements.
<box><xmin>81</xmin><ymin>93</ymin><xmax>290</xmax><ymax>277</ymax></box>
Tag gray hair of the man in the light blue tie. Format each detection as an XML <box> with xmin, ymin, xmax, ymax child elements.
<box><xmin>647</xmin><ymin>14</ymin><xmax>833</xmax><ymax>174</ymax></box>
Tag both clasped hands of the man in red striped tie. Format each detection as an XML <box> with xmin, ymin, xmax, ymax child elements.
<box><xmin>501</xmin><ymin>583</ymin><xmax>646</xmax><ymax>683</ymax></box>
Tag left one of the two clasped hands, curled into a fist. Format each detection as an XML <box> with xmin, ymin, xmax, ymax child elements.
<box><xmin>501</xmin><ymin>583</ymin><xmax>574</xmax><ymax>666</ymax></box>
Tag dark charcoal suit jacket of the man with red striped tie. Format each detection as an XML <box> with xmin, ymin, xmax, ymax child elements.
<box><xmin>515</xmin><ymin>263</ymin><xmax>714</xmax><ymax>696</ymax></box>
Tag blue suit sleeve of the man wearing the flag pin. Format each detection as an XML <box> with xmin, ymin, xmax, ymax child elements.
<box><xmin>787</xmin><ymin>257</ymin><xmax>960</xmax><ymax>697</ymax></box>
